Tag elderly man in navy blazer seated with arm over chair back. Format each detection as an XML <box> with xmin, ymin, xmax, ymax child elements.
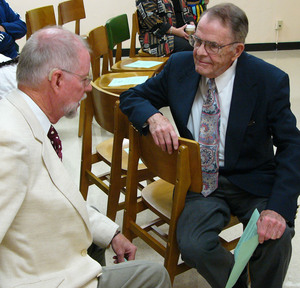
<box><xmin>120</xmin><ymin>4</ymin><xmax>300</xmax><ymax>288</ymax></box>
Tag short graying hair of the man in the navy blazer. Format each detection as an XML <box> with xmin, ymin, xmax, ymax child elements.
<box><xmin>201</xmin><ymin>3</ymin><xmax>248</xmax><ymax>43</ymax></box>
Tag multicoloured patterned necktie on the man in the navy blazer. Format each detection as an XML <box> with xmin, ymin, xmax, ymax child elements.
<box><xmin>198</xmin><ymin>79</ymin><xmax>220</xmax><ymax>197</ymax></box>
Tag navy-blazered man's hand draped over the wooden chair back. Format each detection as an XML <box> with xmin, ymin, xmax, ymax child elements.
<box><xmin>147</xmin><ymin>113</ymin><xmax>179</xmax><ymax>154</ymax></box>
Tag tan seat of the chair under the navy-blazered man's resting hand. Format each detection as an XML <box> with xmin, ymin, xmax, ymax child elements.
<box><xmin>142</xmin><ymin>179</ymin><xmax>174</xmax><ymax>223</ymax></box>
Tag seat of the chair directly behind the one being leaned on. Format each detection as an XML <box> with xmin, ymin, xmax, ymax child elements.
<box><xmin>96</xmin><ymin>137</ymin><xmax>146</xmax><ymax>171</ymax></box>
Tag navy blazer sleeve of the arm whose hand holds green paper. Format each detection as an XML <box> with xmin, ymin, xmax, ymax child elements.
<box><xmin>267</xmin><ymin>73</ymin><xmax>300</xmax><ymax>223</ymax></box>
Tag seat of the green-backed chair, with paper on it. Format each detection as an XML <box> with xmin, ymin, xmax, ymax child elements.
<box><xmin>111</xmin><ymin>57</ymin><xmax>169</xmax><ymax>72</ymax></box>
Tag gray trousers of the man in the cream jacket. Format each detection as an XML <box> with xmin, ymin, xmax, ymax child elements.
<box><xmin>98</xmin><ymin>260</ymin><xmax>171</xmax><ymax>288</ymax></box>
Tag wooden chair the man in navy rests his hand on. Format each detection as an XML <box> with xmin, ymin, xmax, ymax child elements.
<box><xmin>123</xmin><ymin>126</ymin><xmax>239</xmax><ymax>282</ymax></box>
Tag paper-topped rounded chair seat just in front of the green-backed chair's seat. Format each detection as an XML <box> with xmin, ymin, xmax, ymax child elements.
<box><xmin>95</xmin><ymin>71</ymin><xmax>154</xmax><ymax>94</ymax></box>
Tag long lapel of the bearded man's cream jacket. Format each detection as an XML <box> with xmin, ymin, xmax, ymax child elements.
<box><xmin>7</xmin><ymin>90</ymin><xmax>90</xmax><ymax>228</ymax></box>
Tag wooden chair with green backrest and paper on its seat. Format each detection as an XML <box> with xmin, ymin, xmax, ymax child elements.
<box><xmin>105</xmin><ymin>14</ymin><xmax>169</xmax><ymax>73</ymax></box>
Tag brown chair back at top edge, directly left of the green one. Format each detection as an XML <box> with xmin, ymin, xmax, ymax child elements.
<box><xmin>58</xmin><ymin>0</ymin><xmax>86</xmax><ymax>35</ymax></box>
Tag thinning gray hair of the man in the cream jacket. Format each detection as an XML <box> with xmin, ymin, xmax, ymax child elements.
<box><xmin>17</xmin><ymin>26</ymin><xmax>88</xmax><ymax>87</ymax></box>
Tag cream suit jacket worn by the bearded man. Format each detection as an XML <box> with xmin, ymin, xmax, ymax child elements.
<box><xmin>0</xmin><ymin>90</ymin><xmax>118</xmax><ymax>288</ymax></box>
